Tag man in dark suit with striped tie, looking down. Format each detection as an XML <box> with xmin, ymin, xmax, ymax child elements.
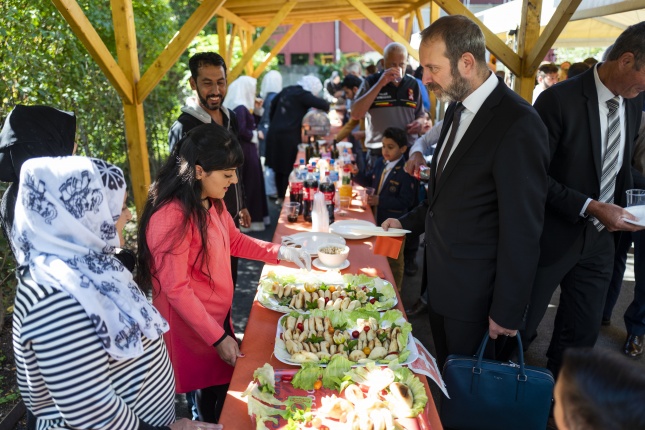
<box><xmin>525</xmin><ymin>22</ymin><xmax>645</xmax><ymax>374</ymax></box>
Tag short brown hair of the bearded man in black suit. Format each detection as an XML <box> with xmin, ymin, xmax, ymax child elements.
<box><xmin>421</xmin><ymin>15</ymin><xmax>488</xmax><ymax>70</ymax></box>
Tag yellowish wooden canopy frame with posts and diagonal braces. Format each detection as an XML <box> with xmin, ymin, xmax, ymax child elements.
<box><xmin>52</xmin><ymin>0</ymin><xmax>624</xmax><ymax>212</ymax></box>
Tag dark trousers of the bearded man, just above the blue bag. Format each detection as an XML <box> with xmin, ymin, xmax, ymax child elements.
<box><xmin>428</xmin><ymin>303</ymin><xmax>506</xmax><ymax>369</ymax></box>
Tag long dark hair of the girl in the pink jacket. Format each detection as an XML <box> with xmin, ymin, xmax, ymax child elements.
<box><xmin>136</xmin><ymin>123</ymin><xmax>244</xmax><ymax>291</ymax></box>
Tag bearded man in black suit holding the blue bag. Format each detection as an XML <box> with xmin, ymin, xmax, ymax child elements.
<box><xmin>382</xmin><ymin>15</ymin><xmax>548</xmax><ymax>365</ymax></box>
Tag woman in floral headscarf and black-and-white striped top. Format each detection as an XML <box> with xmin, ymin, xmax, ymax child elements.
<box><xmin>12</xmin><ymin>157</ymin><xmax>221</xmax><ymax>430</ymax></box>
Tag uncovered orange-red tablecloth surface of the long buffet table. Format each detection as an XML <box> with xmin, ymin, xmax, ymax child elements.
<box><xmin>219</xmin><ymin>193</ymin><xmax>443</xmax><ymax>430</ymax></box>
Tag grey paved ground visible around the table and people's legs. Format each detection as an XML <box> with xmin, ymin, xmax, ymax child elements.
<box><xmin>177</xmin><ymin>202</ymin><xmax>645</xmax><ymax>424</ymax></box>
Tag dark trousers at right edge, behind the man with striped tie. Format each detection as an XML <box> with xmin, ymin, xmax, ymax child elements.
<box><xmin>603</xmin><ymin>231</ymin><xmax>645</xmax><ymax>336</ymax></box>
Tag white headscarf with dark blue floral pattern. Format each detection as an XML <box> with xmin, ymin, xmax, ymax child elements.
<box><xmin>12</xmin><ymin>157</ymin><xmax>168</xmax><ymax>360</ymax></box>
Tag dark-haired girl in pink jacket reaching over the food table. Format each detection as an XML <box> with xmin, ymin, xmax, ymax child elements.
<box><xmin>138</xmin><ymin>124</ymin><xmax>311</xmax><ymax>422</ymax></box>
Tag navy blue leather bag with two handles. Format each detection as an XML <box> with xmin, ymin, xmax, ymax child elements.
<box><xmin>441</xmin><ymin>332</ymin><xmax>555</xmax><ymax>430</ymax></box>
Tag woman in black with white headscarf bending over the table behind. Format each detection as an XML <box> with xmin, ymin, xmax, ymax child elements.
<box><xmin>266</xmin><ymin>75</ymin><xmax>329</xmax><ymax>204</ymax></box>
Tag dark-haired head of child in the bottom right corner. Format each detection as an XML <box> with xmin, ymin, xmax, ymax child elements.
<box><xmin>558</xmin><ymin>348</ymin><xmax>645</xmax><ymax>430</ymax></box>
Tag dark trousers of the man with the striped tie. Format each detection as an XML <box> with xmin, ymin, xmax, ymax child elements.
<box><xmin>522</xmin><ymin>222</ymin><xmax>614</xmax><ymax>375</ymax></box>
